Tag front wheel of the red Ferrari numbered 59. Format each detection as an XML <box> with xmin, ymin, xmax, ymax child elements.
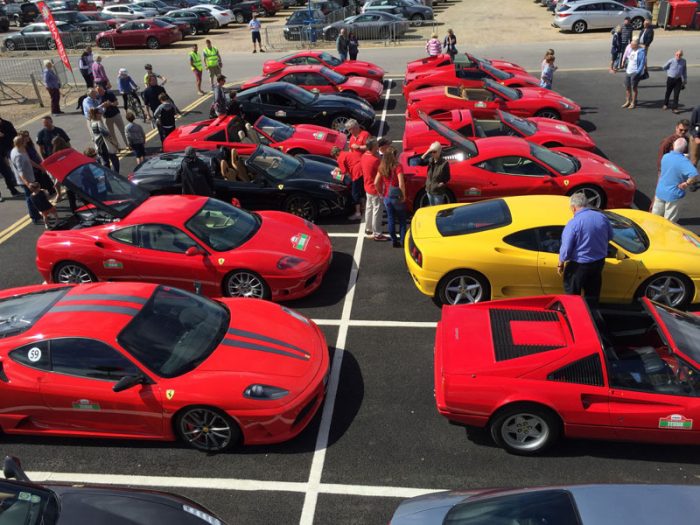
<box><xmin>173</xmin><ymin>405</ymin><xmax>242</xmax><ymax>452</ymax></box>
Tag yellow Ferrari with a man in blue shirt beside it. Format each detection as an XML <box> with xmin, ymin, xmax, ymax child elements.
<box><xmin>404</xmin><ymin>195</ymin><xmax>700</xmax><ymax>308</ymax></box>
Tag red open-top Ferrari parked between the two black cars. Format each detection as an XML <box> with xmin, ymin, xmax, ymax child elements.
<box><xmin>163</xmin><ymin>115</ymin><xmax>347</xmax><ymax>157</ymax></box>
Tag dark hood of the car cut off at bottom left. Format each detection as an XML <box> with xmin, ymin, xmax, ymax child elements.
<box><xmin>50</xmin><ymin>486</ymin><xmax>224</xmax><ymax>525</ymax></box>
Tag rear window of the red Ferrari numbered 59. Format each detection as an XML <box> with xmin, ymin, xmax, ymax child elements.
<box><xmin>0</xmin><ymin>287</ymin><xmax>70</xmax><ymax>336</ymax></box>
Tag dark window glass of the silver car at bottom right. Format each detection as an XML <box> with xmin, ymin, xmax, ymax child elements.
<box><xmin>443</xmin><ymin>490</ymin><xmax>581</xmax><ymax>525</ymax></box>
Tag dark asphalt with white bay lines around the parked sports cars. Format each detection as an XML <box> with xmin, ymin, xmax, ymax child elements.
<box><xmin>0</xmin><ymin>66</ymin><xmax>700</xmax><ymax>525</ymax></box>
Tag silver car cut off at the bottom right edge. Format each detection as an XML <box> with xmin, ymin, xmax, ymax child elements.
<box><xmin>390</xmin><ymin>485</ymin><xmax>700</xmax><ymax>525</ymax></box>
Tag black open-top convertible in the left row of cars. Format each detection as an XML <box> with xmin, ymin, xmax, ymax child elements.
<box><xmin>129</xmin><ymin>145</ymin><xmax>350</xmax><ymax>221</ymax></box>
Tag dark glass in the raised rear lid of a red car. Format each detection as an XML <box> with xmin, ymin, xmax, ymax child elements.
<box><xmin>64</xmin><ymin>162</ymin><xmax>148</xmax><ymax>219</ymax></box>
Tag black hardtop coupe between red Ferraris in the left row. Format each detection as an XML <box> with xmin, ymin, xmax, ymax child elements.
<box><xmin>236</xmin><ymin>82</ymin><xmax>375</xmax><ymax>131</ymax></box>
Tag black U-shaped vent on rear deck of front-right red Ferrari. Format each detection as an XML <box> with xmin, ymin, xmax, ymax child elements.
<box><xmin>489</xmin><ymin>308</ymin><xmax>560</xmax><ymax>361</ymax></box>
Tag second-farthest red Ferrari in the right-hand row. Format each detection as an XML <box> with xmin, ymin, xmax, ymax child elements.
<box><xmin>403</xmin><ymin>55</ymin><xmax>540</xmax><ymax>97</ymax></box>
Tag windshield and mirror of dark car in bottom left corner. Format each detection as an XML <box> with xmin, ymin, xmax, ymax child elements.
<box><xmin>0</xmin><ymin>481</ymin><xmax>58</xmax><ymax>525</ymax></box>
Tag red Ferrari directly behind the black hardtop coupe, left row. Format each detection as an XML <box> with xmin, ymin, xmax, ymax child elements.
<box><xmin>241</xmin><ymin>66</ymin><xmax>384</xmax><ymax>104</ymax></box>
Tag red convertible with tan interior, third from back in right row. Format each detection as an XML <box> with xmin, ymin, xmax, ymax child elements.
<box><xmin>406</xmin><ymin>80</ymin><xmax>581</xmax><ymax>124</ymax></box>
